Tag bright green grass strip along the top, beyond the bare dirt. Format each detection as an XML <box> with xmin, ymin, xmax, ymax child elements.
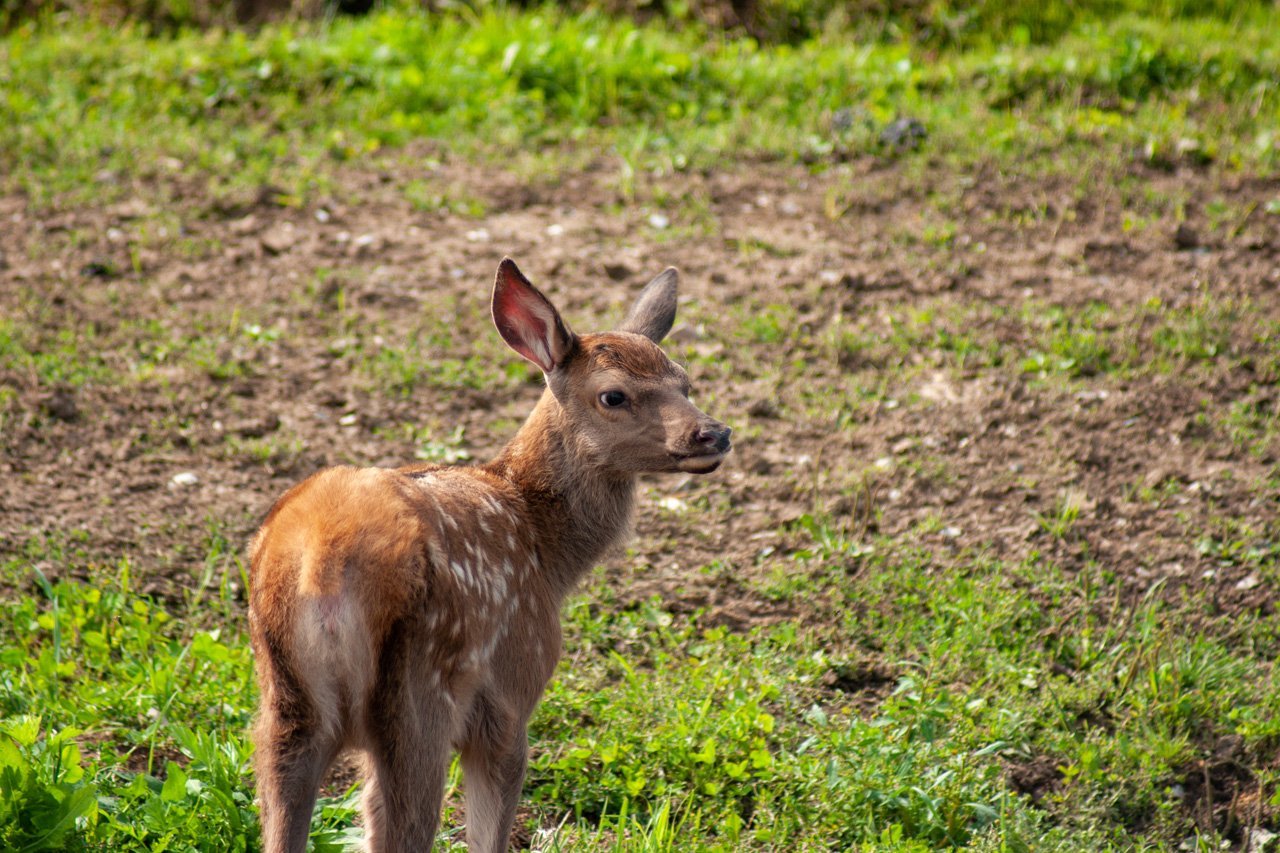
<box><xmin>0</xmin><ymin>6</ymin><xmax>1280</xmax><ymax>211</ymax></box>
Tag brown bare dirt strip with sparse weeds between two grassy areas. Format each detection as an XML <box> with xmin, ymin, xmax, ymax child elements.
<box><xmin>0</xmin><ymin>149</ymin><xmax>1280</xmax><ymax>626</ymax></box>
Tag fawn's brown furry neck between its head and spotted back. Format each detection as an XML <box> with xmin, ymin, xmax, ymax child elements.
<box><xmin>486</xmin><ymin>391</ymin><xmax>636</xmax><ymax>596</ymax></box>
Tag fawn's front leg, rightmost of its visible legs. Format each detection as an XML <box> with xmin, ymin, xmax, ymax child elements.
<box><xmin>461</xmin><ymin>697</ymin><xmax>529</xmax><ymax>853</ymax></box>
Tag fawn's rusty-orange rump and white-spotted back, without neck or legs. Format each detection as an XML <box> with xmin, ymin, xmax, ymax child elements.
<box><xmin>250</xmin><ymin>467</ymin><xmax>550</xmax><ymax>706</ymax></box>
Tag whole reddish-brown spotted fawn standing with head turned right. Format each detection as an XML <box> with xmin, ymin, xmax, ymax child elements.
<box><xmin>250</xmin><ymin>259</ymin><xmax>730</xmax><ymax>853</ymax></box>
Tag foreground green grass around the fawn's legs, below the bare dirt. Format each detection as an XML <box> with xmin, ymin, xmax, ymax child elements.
<box><xmin>0</xmin><ymin>521</ymin><xmax>1280</xmax><ymax>850</ymax></box>
